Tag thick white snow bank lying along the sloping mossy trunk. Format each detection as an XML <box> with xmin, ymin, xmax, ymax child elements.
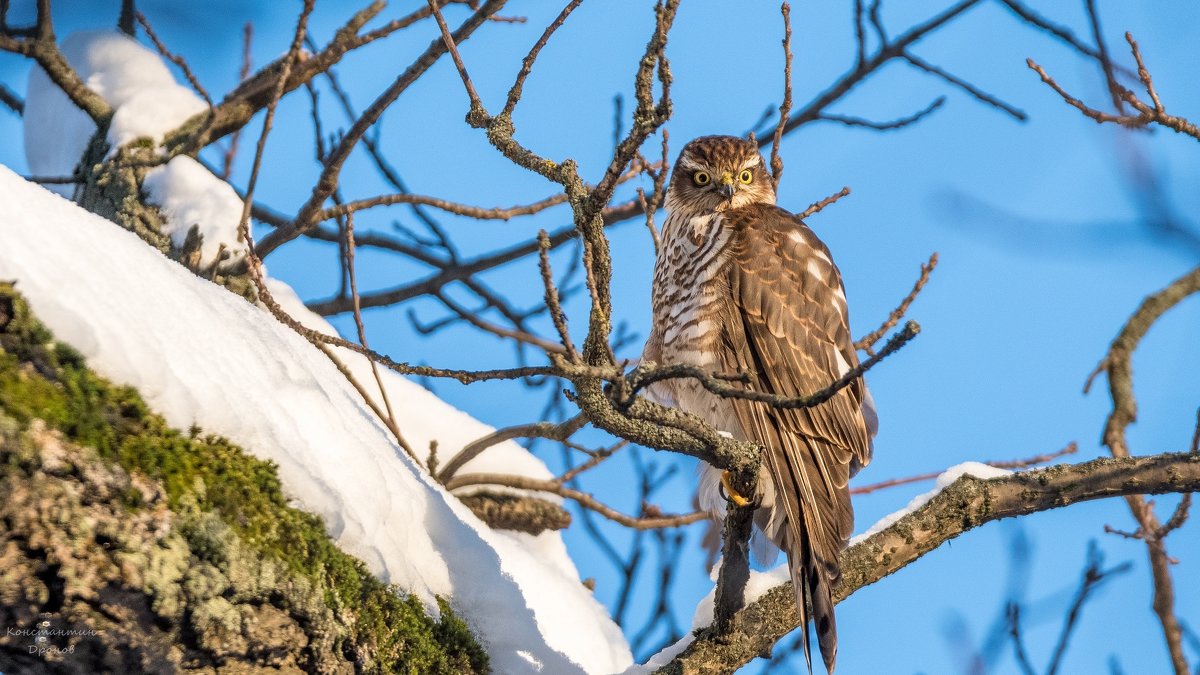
<box><xmin>0</xmin><ymin>167</ymin><xmax>632</xmax><ymax>674</ymax></box>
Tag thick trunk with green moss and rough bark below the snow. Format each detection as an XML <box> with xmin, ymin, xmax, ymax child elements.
<box><xmin>0</xmin><ymin>285</ymin><xmax>488</xmax><ymax>674</ymax></box>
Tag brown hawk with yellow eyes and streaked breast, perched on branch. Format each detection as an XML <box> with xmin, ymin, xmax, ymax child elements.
<box><xmin>642</xmin><ymin>136</ymin><xmax>877</xmax><ymax>673</ymax></box>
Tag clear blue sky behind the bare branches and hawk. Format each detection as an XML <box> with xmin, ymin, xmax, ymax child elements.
<box><xmin>0</xmin><ymin>0</ymin><xmax>1200</xmax><ymax>674</ymax></box>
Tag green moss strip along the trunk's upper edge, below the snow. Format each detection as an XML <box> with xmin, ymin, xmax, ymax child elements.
<box><xmin>0</xmin><ymin>283</ymin><xmax>488</xmax><ymax>674</ymax></box>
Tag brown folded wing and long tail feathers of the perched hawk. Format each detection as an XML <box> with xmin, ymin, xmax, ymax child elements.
<box><xmin>721</xmin><ymin>205</ymin><xmax>870</xmax><ymax>671</ymax></box>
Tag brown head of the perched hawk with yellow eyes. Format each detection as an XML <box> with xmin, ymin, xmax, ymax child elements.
<box><xmin>667</xmin><ymin>136</ymin><xmax>775</xmax><ymax>213</ymax></box>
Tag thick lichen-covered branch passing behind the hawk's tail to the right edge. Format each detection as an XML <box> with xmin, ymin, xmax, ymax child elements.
<box><xmin>656</xmin><ymin>454</ymin><xmax>1200</xmax><ymax>674</ymax></box>
